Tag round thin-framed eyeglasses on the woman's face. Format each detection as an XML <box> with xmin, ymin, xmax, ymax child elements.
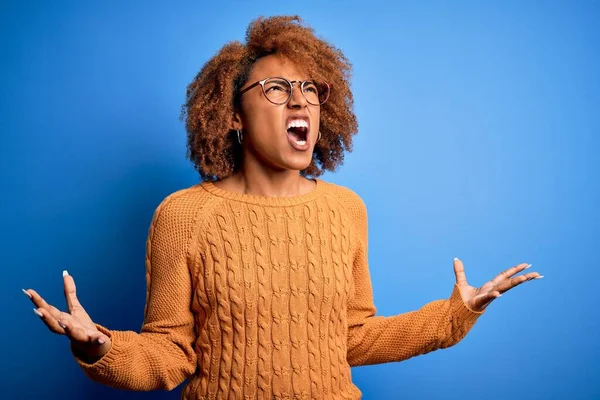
<box><xmin>240</xmin><ymin>77</ymin><xmax>331</xmax><ymax>106</ymax></box>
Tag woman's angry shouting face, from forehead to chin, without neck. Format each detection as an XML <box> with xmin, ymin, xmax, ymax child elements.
<box><xmin>234</xmin><ymin>55</ymin><xmax>321</xmax><ymax>172</ymax></box>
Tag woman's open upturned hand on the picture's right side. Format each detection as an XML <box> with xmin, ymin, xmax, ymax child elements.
<box><xmin>454</xmin><ymin>258</ymin><xmax>543</xmax><ymax>312</ymax></box>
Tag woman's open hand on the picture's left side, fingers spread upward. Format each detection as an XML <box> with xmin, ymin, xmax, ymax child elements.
<box><xmin>23</xmin><ymin>271</ymin><xmax>111</xmax><ymax>363</ymax></box>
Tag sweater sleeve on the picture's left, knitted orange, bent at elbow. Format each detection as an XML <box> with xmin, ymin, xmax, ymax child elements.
<box><xmin>71</xmin><ymin>194</ymin><xmax>196</xmax><ymax>391</ymax></box>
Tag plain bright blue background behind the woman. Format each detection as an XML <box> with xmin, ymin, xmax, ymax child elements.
<box><xmin>0</xmin><ymin>1</ymin><xmax>600</xmax><ymax>400</ymax></box>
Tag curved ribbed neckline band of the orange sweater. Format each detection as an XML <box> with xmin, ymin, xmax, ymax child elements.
<box><xmin>200</xmin><ymin>178</ymin><xmax>325</xmax><ymax>207</ymax></box>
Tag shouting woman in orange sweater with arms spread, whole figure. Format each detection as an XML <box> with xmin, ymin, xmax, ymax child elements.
<box><xmin>25</xmin><ymin>17</ymin><xmax>540</xmax><ymax>399</ymax></box>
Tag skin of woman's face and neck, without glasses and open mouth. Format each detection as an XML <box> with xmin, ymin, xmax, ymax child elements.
<box><xmin>215</xmin><ymin>55</ymin><xmax>320</xmax><ymax>197</ymax></box>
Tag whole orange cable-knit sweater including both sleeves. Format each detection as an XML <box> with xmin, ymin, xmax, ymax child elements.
<box><xmin>75</xmin><ymin>180</ymin><xmax>481</xmax><ymax>399</ymax></box>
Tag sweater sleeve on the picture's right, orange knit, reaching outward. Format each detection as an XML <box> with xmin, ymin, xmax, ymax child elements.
<box><xmin>347</xmin><ymin>190</ymin><xmax>483</xmax><ymax>366</ymax></box>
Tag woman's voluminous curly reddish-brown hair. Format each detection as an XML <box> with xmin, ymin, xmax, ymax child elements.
<box><xmin>181</xmin><ymin>16</ymin><xmax>358</xmax><ymax>180</ymax></box>
